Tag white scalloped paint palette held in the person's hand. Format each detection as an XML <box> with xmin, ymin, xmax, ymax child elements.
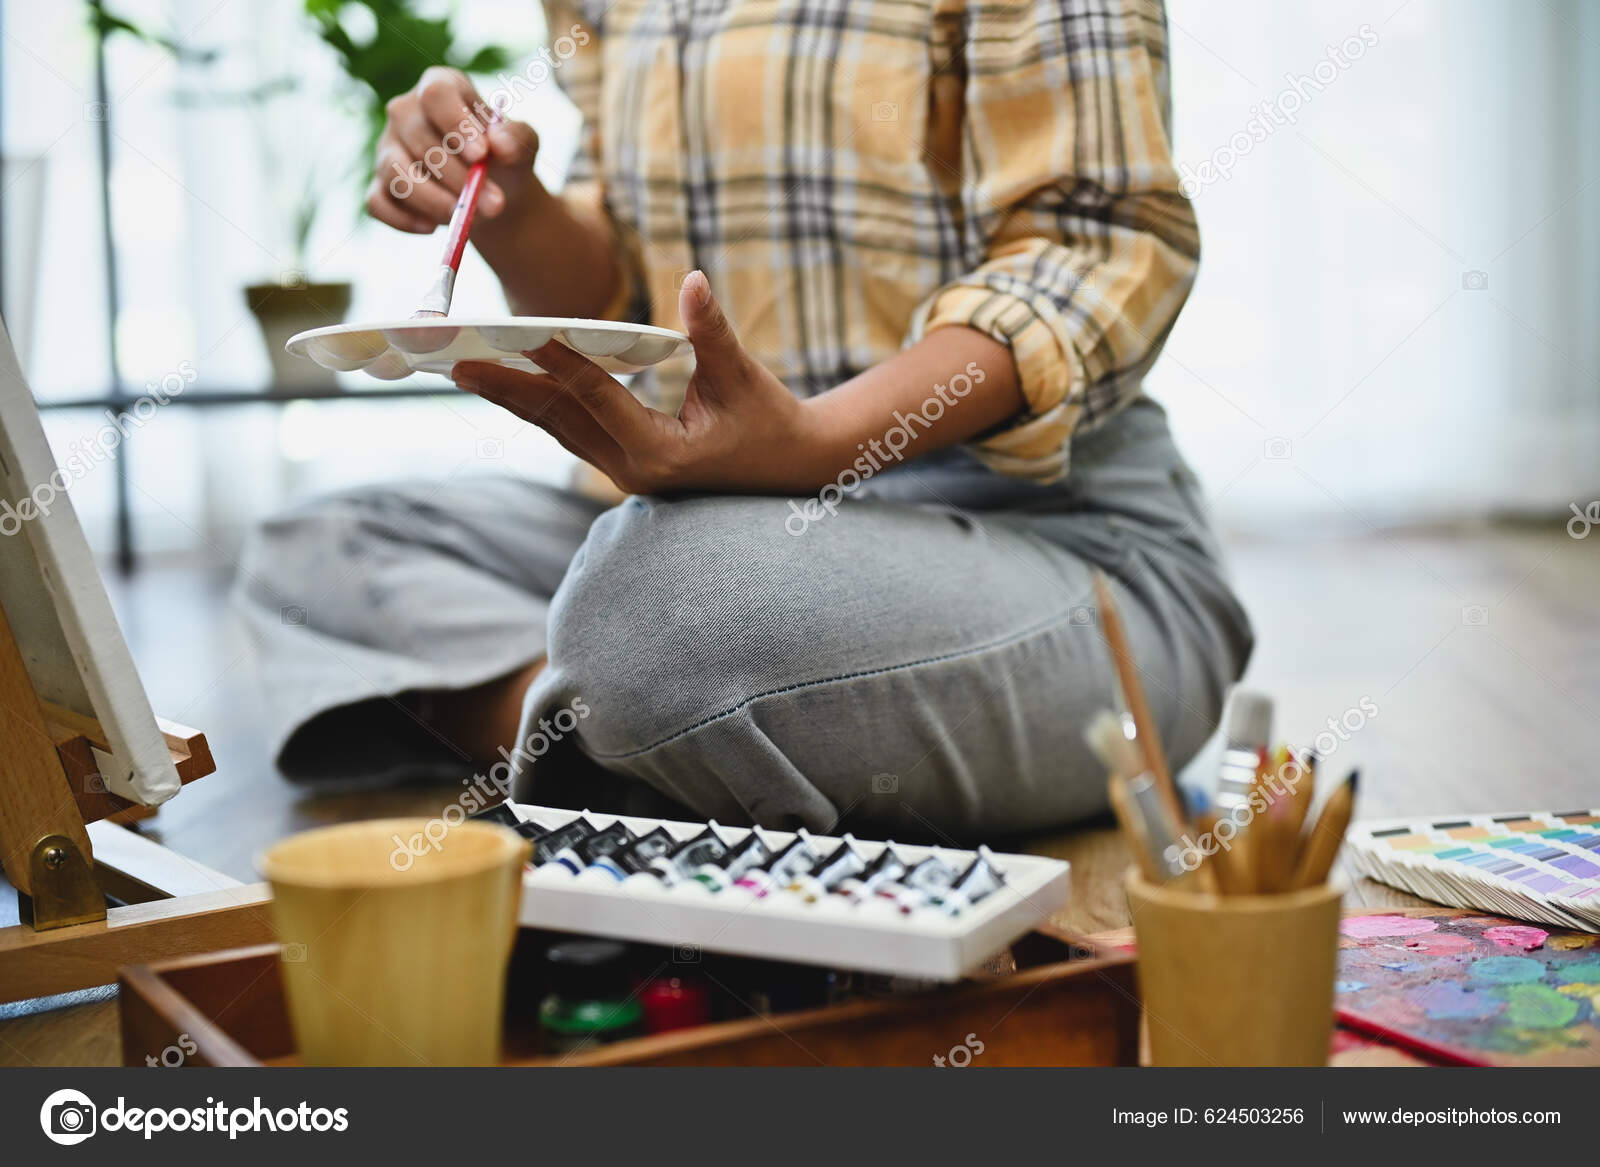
<box><xmin>285</xmin><ymin>315</ymin><xmax>690</xmax><ymax>381</ymax></box>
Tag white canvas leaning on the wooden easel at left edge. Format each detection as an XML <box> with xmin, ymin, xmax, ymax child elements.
<box><xmin>0</xmin><ymin>320</ymin><xmax>179</xmax><ymax>807</ymax></box>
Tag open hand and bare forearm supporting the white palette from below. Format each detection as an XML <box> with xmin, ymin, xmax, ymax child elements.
<box><xmin>451</xmin><ymin>271</ymin><xmax>1024</xmax><ymax>499</ymax></box>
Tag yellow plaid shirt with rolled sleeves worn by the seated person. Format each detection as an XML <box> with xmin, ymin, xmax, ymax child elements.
<box><xmin>546</xmin><ymin>0</ymin><xmax>1200</xmax><ymax>480</ymax></box>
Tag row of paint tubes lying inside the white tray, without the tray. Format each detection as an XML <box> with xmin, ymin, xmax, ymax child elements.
<box><xmin>514</xmin><ymin>812</ymin><xmax>1005</xmax><ymax>917</ymax></box>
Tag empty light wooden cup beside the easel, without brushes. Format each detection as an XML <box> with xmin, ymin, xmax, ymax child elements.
<box><xmin>258</xmin><ymin>818</ymin><xmax>528</xmax><ymax>1066</ymax></box>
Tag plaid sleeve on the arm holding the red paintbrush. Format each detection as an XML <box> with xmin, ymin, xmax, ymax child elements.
<box><xmin>544</xmin><ymin>0</ymin><xmax>650</xmax><ymax>323</ymax></box>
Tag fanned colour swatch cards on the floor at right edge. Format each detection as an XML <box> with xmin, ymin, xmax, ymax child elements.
<box><xmin>1347</xmin><ymin>810</ymin><xmax>1600</xmax><ymax>932</ymax></box>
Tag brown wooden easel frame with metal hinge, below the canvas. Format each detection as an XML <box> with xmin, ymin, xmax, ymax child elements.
<box><xmin>0</xmin><ymin>595</ymin><xmax>274</xmax><ymax>1004</ymax></box>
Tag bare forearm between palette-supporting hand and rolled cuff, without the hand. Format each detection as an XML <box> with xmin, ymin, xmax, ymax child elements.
<box><xmin>797</xmin><ymin>327</ymin><xmax>1027</xmax><ymax>488</ymax></box>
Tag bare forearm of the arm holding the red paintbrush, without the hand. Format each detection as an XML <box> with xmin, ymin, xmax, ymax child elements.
<box><xmin>472</xmin><ymin>181</ymin><xmax>621</xmax><ymax>317</ymax></box>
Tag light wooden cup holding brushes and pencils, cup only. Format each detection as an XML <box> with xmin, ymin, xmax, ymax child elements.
<box><xmin>1126</xmin><ymin>871</ymin><xmax>1344</xmax><ymax>1066</ymax></box>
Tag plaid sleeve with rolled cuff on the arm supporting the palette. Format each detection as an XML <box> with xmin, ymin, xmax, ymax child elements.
<box><xmin>907</xmin><ymin>0</ymin><xmax>1200</xmax><ymax>480</ymax></box>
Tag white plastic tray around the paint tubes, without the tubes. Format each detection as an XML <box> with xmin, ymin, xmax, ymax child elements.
<box><xmin>515</xmin><ymin>805</ymin><xmax>1070</xmax><ymax>981</ymax></box>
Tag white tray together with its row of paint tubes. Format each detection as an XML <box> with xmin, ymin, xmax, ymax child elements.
<box><xmin>477</xmin><ymin>804</ymin><xmax>1070</xmax><ymax>981</ymax></box>
